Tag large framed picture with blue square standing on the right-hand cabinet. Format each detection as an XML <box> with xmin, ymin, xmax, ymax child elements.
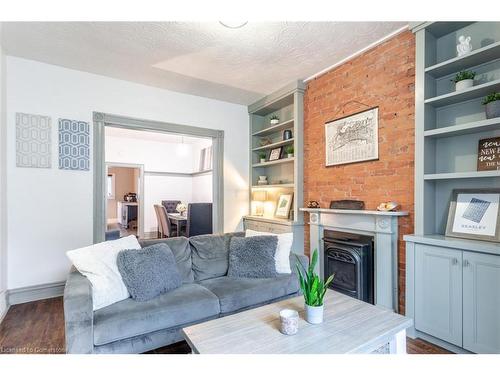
<box><xmin>446</xmin><ymin>189</ymin><xmax>500</xmax><ymax>242</ymax></box>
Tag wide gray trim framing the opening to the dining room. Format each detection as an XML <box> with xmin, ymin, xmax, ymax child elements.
<box><xmin>93</xmin><ymin>112</ymin><xmax>224</xmax><ymax>243</ymax></box>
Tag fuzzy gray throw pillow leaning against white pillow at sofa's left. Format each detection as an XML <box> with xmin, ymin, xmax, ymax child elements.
<box><xmin>116</xmin><ymin>243</ymin><xmax>182</xmax><ymax>301</ymax></box>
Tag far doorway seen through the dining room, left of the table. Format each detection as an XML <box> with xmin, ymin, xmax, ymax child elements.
<box><xmin>106</xmin><ymin>162</ymin><xmax>144</xmax><ymax>238</ymax></box>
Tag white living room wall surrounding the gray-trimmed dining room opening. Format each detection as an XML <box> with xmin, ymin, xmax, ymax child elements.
<box><xmin>6</xmin><ymin>56</ymin><xmax>248</xmax><ymax>289</ymax></box>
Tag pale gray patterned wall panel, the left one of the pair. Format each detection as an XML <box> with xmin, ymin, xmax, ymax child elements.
<box><xmin>16</xmin><ymin>113</ymin><xmax>52</xmax><ymax>168</ymax></box>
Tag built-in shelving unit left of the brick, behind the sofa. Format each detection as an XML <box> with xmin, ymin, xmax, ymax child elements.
<box><xmin>243</xmin><ymin>81</ymin><xmax>305</xmax><ymax>254</ymax></box>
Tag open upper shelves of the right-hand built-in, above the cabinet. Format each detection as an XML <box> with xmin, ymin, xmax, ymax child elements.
<box><xmin>413</xmin><ymin>22</ymin><xmax>500</xmax><ymax>236</ymax></box>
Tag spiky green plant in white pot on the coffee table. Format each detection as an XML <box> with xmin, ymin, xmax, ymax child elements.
<box><xmin>297</xmin><ymin>249</ymin><xmax>334</xmax><ymax>324</ymax></box>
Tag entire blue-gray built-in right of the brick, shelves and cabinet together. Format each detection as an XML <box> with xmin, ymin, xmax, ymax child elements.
<box><xmin>404</xmin><ymin>22</ymin><xmax>500</xmax><ymax>354</ymax></box>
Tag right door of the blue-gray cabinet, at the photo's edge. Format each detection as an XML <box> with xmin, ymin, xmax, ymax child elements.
<box><xmin>463</xmin><ymin>251</ymin><xmax>500</xmax><ymax>353</ymax></box>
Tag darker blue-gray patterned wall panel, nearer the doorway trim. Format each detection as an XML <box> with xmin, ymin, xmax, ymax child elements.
<box><xmin>59</xmin><ymin>119</ymin><xmax>90</xmax><ymax>171</ymax></box>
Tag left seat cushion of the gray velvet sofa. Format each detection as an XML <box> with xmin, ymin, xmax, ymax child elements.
<box><xmin>94</xmin><ymin>284</ymin><xmax>220</xmax><ymax>345</ymax></box>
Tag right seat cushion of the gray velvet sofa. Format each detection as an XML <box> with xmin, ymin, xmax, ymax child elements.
<box><xmin>200</xmin><ymin>273</ymin><xmax>299</xmax><ymax>314</ymax></box>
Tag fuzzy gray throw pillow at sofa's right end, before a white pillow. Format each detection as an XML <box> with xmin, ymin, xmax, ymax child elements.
<box><xmin>227</xmin><ymin>236</ymin><xmax>278</xmax><ymax>278</ymax></box>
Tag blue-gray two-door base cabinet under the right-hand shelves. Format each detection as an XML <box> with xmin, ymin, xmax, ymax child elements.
<box><xmin>405</xmin><ymin>235</ymin><xmax>500</xmax><ymax>354</ymax></box>
